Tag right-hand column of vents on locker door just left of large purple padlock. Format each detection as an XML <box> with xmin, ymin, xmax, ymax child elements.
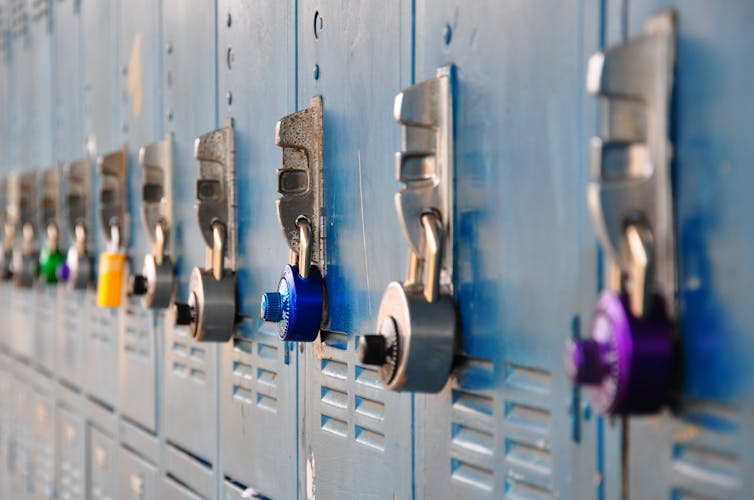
<box><xmin>502</xmin><ymin>361</ymin><xmax>555</xmax><ymax>498</ymax></box>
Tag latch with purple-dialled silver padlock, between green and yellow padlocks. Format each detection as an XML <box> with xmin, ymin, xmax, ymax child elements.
<box><xmin>58</xmin><ymin>158</ymin><xmax>94</xmax><ymax>290</ymax></box>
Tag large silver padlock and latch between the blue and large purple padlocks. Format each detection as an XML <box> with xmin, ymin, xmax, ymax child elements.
<box><xmin>358</xmin><ymin>66</ymin><xmax>458</xmax><ymax>392</ymax></box>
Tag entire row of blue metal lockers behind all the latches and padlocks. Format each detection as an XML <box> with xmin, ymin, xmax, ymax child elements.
<box><xmin>0</xmin><ymin>0</ymin><xmax>754</xmax><ymax>499</ymax></box>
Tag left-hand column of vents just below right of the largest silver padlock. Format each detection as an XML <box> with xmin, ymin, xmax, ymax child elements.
<box><xmin>450</xmin><ymin>358</ymin><xmax>497</xmax><ymax>491</ymax></box>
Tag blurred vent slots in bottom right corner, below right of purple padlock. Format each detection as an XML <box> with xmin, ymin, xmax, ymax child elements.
<box><xmin>671</xmin><ymin>402</ymin><xmax>743</xmax><ymax>499</ymax></box>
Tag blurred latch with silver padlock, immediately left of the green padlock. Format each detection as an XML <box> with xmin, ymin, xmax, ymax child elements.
<box><xmin>8</xmin><ymin>172</ymin><xmax>39</xmax><ymax>288</ymax></box>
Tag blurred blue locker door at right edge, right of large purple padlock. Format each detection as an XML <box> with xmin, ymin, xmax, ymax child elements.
<box><xmin>627</xmin><ymin>0</ymin><xmax>754</xmax><ymax>498</ymax></box>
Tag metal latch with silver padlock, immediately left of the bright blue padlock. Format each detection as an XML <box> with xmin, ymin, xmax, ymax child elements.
<box><xmin>175</xmin><ymin>119</ymin><xmax>238</xmax><ymax>342</ymax></box>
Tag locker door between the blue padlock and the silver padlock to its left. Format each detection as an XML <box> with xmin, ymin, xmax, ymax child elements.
<box><xmin>214</xmin><ymin>0</ymin><xmax>298</xmax><ymax>498</ymax></box>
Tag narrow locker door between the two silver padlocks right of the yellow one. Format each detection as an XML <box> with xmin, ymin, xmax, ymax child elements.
<box><xmin>161</xmin><ymin>0</ymin><xmax>219</xmax><ymax>470</ymax></box>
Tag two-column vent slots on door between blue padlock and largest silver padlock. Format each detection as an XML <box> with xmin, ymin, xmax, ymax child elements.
<box><xmin>315</xmin><ymin>332</ymin><xmax>385</xmax><ymax>452</ymax></box>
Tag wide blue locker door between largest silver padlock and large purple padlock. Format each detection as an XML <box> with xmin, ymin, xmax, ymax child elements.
<box><xmin>414</xmin><ymin>1</ymin><xmax>606</xmax><ymax>498</ymax></box>
